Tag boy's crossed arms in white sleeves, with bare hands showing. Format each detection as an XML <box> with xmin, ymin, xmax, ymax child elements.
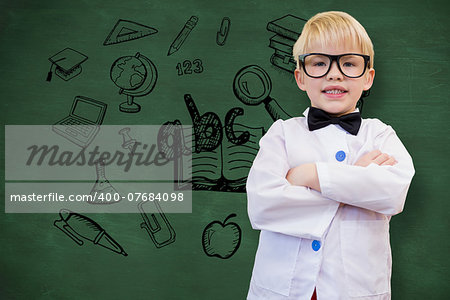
<box><xmin>246</xmin><ymin>120</ymin><xmax>414</xmax><ymax>239</ymax></box>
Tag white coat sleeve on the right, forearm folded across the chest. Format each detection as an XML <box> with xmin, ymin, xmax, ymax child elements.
<box><xmin>316</xmin><ymin>125</ymin><xmax>415</xmax><ymax>215</ymax></box>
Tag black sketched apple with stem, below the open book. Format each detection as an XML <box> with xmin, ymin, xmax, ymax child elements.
<box><xmin>202</xmin><ymin>214</ymin><xmax>242</xmax><ymax>259</ymax></box>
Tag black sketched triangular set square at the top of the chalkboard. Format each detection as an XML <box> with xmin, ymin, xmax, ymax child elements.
<box><xmin>103</xmin><ymin>20</ymin><xmax>158</xmax><ymax>46</ymax></box>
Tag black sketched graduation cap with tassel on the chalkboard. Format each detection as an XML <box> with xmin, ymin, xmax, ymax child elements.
<box><xmin>47</xmin><ymin>48</ymin><xmax>88</xmax><ymax>81</ymax></box>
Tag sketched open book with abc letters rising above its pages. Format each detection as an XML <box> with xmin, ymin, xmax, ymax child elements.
<box><xmin>174</xmin><ymin>95</ymin><xmax>265</xmax><ymax>193</ymax></box>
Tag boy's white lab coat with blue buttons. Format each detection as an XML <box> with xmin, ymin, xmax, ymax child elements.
<box><xmin>247</xmin><ymin>109</ymin><xmax>415</xmax><ymax>300</ymax></box>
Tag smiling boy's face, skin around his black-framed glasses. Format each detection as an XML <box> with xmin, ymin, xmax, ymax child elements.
<box><xmin>295</xmin><ymin>43</ymin><xmax>375</xmax><ymax>116</ymax></box>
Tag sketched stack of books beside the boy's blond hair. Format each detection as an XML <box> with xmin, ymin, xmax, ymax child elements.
<box><xmin>267</xmin><ymin>15</ymin><xmax>307</xmax><ymax>72</ymax></box>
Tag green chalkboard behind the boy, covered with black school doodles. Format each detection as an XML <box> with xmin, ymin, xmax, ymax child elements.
<box><xmin>0</xmin><ymin>0</ymin><xmax>450</xmax><ymax>300</ymax></box>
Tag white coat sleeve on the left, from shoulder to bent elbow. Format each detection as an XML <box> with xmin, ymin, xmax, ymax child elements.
<box><xmin>246</xmin><ymin>120</ymin><xmax>339</xmax><ymax>240</ymax></box>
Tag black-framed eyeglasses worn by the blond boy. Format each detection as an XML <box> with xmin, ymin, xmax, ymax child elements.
<box><xmin>298</xmin><ymin>53</ymin><xmax>370</xmax><ymax>78</ymax></box>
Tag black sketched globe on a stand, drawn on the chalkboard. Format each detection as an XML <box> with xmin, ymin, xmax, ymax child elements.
<box><xmin>110</xmin><ymin>52</ymin><xmax>158</xmax><ymax>113</ymax></box>
